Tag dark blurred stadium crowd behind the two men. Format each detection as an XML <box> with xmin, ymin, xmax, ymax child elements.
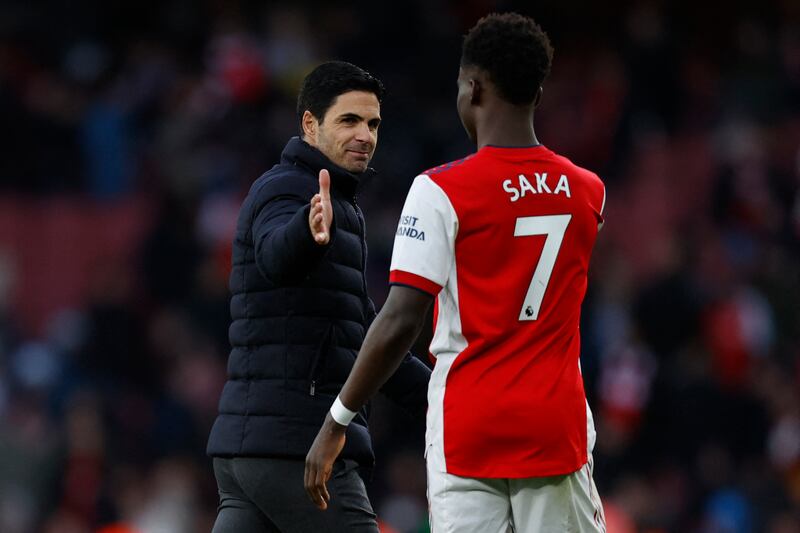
<box><xmin>0</xmin><ymin>0</ymin><xmax>800</xmax><ymax>533</ymax></box>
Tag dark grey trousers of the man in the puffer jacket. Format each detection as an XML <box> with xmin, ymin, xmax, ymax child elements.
<box><xmin>212</xmin><ymin>457</ymin><xmax>378</xmax><ymax>533</ymax></box>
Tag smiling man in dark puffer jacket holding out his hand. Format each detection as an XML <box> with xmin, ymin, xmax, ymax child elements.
<box><xmin>208</xmin><ymin>62</ymin><xmax>430</xmax><ymax>533</ymax></box>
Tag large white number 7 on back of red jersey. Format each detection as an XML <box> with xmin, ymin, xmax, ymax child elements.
<box><xmin>514</xmin><ymin>215</ymin><xmax>572</xmax><ymax>320</ymax></box>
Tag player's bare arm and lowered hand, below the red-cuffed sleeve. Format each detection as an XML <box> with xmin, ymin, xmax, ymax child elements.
<box><xmin>305</xmin><ymin>285</ymin><xmax>433</xmax><ymax>509</ymax></box>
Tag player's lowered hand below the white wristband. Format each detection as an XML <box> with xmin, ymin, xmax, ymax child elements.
<box><xmin>305</xmin><ymin>414</ymin><xmax>347</xmax><ymax>511</ymax></box>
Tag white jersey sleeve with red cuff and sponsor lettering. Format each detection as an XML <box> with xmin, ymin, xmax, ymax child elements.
<box><xmin>389</xmin><ymin>174</ymin><xmax>458</xmax><ymax>296</ymax></box>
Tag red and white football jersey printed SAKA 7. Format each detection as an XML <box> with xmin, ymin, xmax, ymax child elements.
<box><xmin>390</xmin><ymin>146</ymin><xmax>605</xmax><ymax>478</ymax></box>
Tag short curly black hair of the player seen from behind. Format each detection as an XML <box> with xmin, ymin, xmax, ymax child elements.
<box><xmin>461</xmin><ymin>13</ymin><xmax>553</xmax><ymax>105</ymax></box>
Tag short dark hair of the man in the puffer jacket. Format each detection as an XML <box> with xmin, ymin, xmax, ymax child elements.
<box><xmin>297</xmin><ymin>61</ymin><xmax>385</xmax><ymax>128</ymax></box>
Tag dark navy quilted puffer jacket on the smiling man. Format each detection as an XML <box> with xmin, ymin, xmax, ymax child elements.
<box><xmin>207</xmin><ymin>137</ymin><xmax>430</xmax><ymax>466</ymax></box>
